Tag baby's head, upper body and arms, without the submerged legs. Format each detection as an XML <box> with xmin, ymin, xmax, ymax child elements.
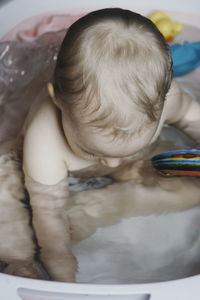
<box><xmin>0</xmin><ymin>8</ymin><xmax>200</xmax><ymax>282</ymax></box>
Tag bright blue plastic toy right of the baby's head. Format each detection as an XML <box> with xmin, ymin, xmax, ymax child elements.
<box><xmin>170</xmin><ymin>41</ymin><xmax>200</xmax><ymax>77</ymax></box>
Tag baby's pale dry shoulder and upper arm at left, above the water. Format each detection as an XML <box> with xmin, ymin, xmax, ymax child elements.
<box><xmin>23</xmin><ymin>98</ymin><xmax>67</xmax><ymax>184</ymax></box>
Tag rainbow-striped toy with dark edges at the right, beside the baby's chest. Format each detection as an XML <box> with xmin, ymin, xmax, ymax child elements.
<box><xmin>152</xmin><ymin>149</ymin><xmax>200</xmax><ymax>176</ymax></box>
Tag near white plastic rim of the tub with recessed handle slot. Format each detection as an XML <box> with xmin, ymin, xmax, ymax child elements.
<box><xmin>0</xmin><ymin>275</ymin><xmax>200</xmax><ymax>300</ymax></box>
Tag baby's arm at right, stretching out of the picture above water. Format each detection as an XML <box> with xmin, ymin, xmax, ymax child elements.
<box><xmin>163</xmin><ymin>81</ymin><xmax>200</xmax><ymax>143</ymax></box>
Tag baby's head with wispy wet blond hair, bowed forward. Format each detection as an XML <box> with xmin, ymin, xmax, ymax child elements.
<box><xmin>53</xmin><ymin>8</ymin><xmax>172</xmax><ymax>166</ymax></box>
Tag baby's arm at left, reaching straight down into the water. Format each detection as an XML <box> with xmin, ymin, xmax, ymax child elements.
<box><xmin>23</xmin><ymin>122</ymin><xmax>76</xmax><ymax>282</ymax></box>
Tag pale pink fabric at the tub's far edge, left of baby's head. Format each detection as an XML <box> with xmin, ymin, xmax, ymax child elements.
<box><xmin>1</xmin><ymin>14</ymin><xmax>83</xmax><ymax>41</ymax></box>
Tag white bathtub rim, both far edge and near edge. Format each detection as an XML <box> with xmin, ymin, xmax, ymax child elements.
<box><xmin>0</xmin><ymin>0</ymin><xmax>200</xmax><ymax>300</ymax></box>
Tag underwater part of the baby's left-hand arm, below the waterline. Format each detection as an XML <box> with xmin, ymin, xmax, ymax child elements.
<box><xmin>25</xmin><ymin>175</ymin><xmax>76</xmax><ymax>282</ymax></box>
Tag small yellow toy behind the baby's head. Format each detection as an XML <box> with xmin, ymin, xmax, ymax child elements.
<box><xmin>149</xmin><ymin>11</ymin><xmax>183</xmax><ymax>42</ymax></box>
